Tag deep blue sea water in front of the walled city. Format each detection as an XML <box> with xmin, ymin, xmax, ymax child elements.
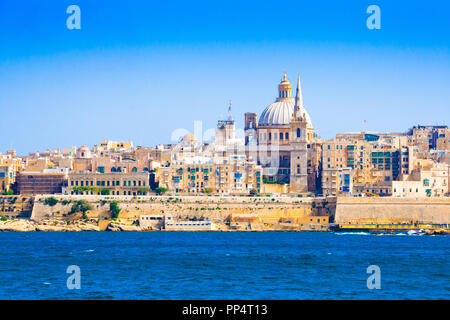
<box><xmin>0</xmin><ymin>232</ymin><xmax>450</xmax><ymax>299</ymax></box>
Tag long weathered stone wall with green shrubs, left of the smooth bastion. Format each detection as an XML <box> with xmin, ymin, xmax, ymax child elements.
<box><xmin>31</xmin><ymin>195</ymin><xmax>334</xmax><ymax>223</ymax></box>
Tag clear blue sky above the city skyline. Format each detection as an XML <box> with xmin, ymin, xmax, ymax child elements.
<box><xmin>0</xmin><ymin>0</ymin><xmax>450</xmax><ymax>154</ymax></box>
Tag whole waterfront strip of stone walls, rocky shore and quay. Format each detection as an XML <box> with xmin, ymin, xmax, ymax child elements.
<box><xmin>0</xmin><ymin>195</ymin><xmax>450</xmax><ymax>233</ymax></box>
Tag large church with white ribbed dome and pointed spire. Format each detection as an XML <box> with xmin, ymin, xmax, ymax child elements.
<box><xmin>244</xmin><ymin>72</ymin><xmax>314</xmax><ymax>193</ymax></box>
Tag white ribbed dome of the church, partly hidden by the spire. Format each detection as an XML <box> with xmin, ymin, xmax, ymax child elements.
<box><xmin>258</xmin><ymin>100</ymin><xmax>312</xmax><ymax>127</ymax></box>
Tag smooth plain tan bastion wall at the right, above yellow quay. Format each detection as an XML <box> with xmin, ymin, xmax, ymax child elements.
<box><xmin>335</xmin><ymin>197</ymin><xmax>450</xmax><ymax>224</ymax></box>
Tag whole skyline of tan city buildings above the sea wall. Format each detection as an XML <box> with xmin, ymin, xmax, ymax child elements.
<box><xmin>0</xmin><ymin>73</ymin><xmax>450</xmax><ymax>197</ymax></box>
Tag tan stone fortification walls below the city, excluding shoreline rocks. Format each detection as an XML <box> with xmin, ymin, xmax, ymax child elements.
<box><xmin>6</xmin><ymin>195</ymin><xmax>450</xmax><ymax>228</ymax></box>
